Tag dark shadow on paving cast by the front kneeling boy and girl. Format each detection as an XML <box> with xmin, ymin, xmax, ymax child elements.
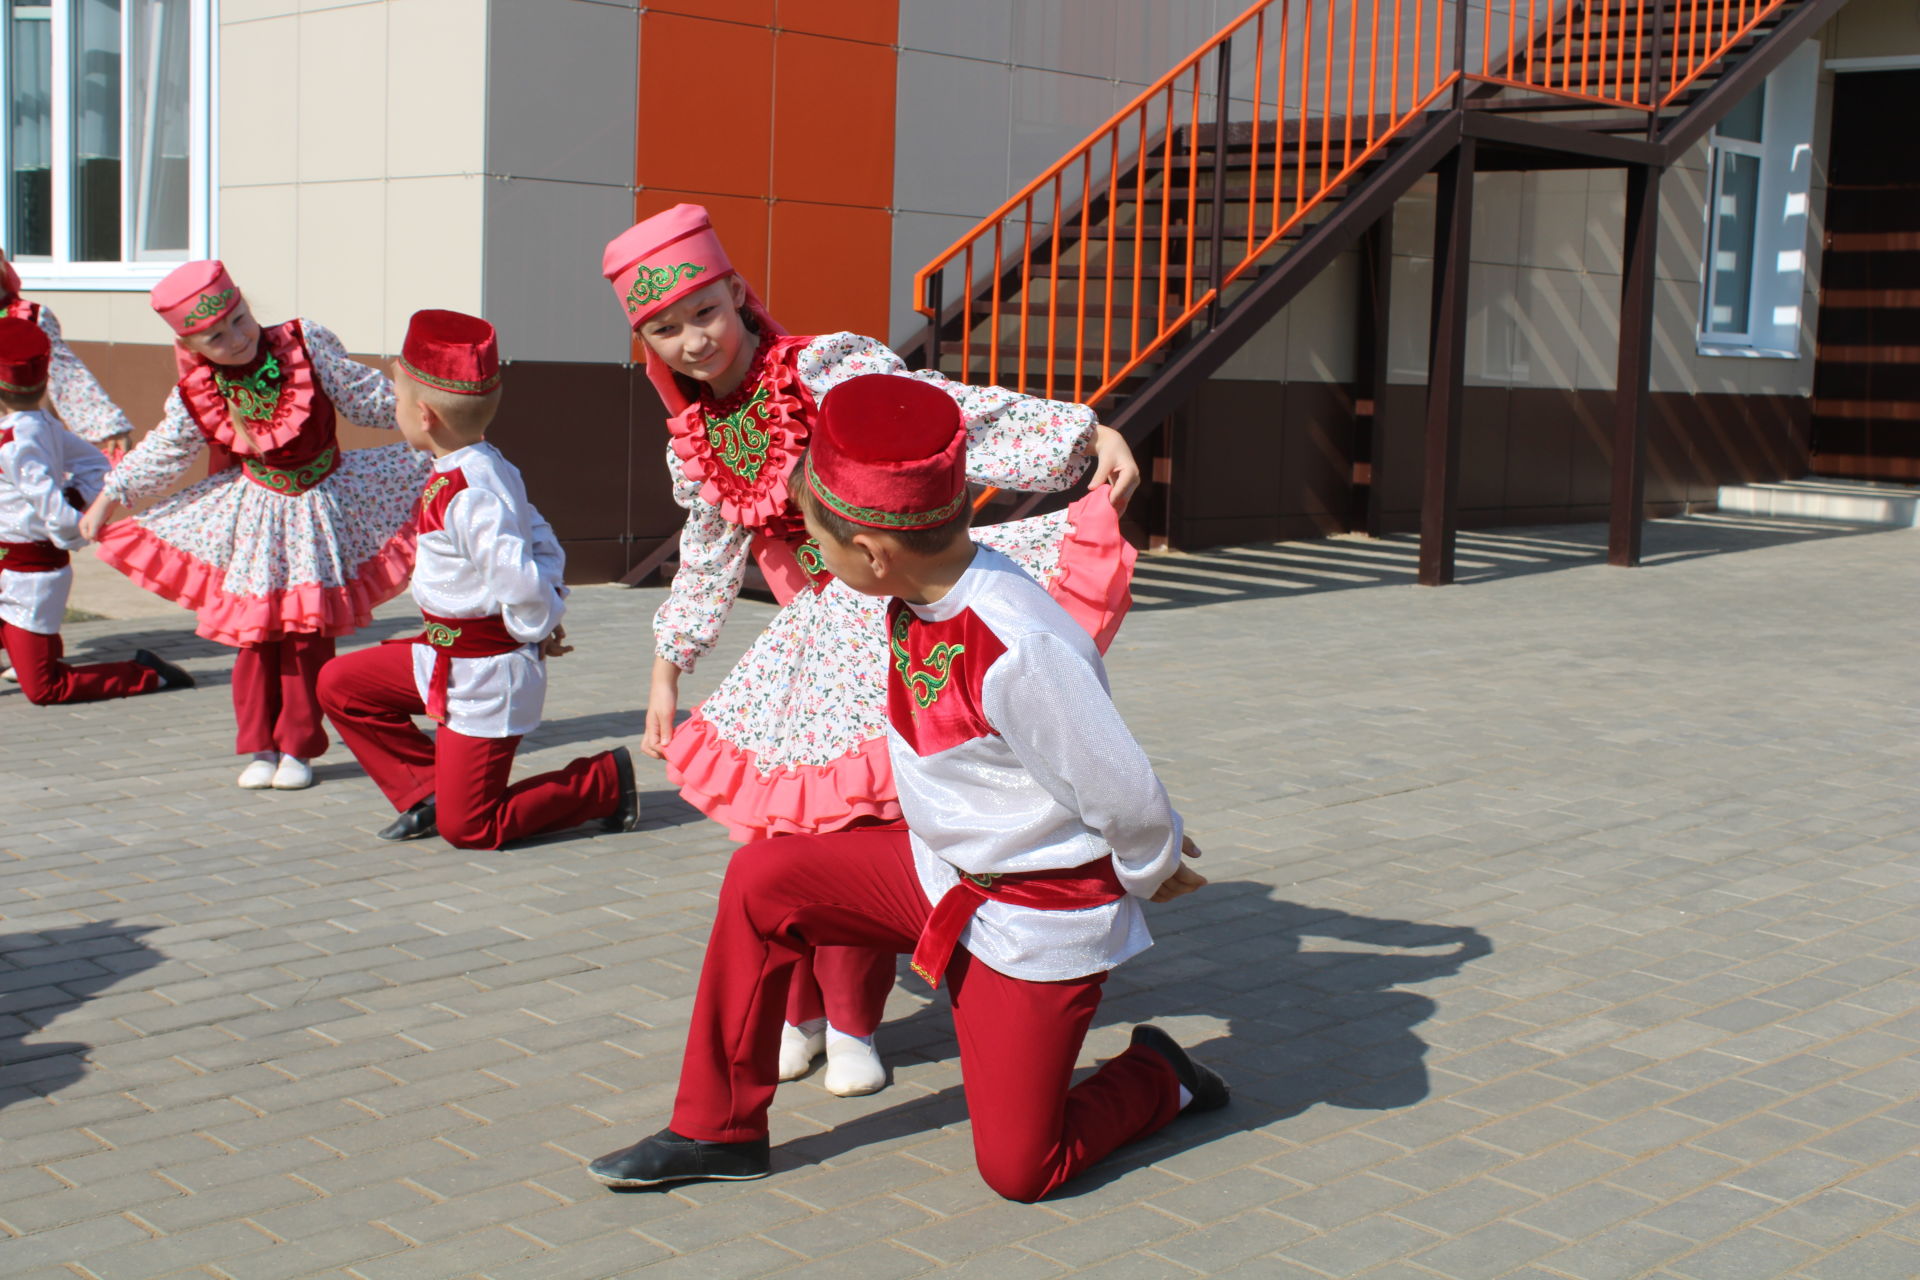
<box><xmin>776</xmin><ymin>881</ymin><xmax>1494</xmax><ymax>1199</ymax></box>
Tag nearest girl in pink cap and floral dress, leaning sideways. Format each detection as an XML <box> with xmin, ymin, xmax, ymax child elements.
<box><xmin>601</xmin><ymin>205</ymin><xmax>1139</xmax><ymax>1096</ymax></box>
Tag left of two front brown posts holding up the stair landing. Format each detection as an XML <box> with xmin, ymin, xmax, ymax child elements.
<box><xmin>1421</xmin><ymin>138</ymin><xmax>1475</xmax><ymax>587</ymax></box>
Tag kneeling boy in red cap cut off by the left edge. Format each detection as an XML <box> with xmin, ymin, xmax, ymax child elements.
<box><xmin>0</xmin><ymin>317</ymin><xmax>194</xmax><ymax>704</ymax></box>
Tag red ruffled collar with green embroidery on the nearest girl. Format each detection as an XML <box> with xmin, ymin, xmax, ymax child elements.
<box><xmin>666</xmin><ymin>334</ymin><xmax>814</xmax><ymax>537</ymax></box>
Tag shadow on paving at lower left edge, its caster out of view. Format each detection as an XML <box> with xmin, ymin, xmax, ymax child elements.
<box><xmin>0</xmin><ymin>921</ymin><xmax>163</xmax><ymax>1109</ymax></box>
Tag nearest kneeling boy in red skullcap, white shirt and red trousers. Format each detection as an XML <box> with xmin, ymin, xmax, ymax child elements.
<box><xmin>589</xmin><ymin>374</ymin><xmax>1227</xmax><ymax>1199</ymax></box>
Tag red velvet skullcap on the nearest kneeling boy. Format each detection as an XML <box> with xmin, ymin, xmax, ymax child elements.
<box><xmin>806</xmin><ymin>374</ymin><xmax>966</xmax><ymax>530</ymax></box>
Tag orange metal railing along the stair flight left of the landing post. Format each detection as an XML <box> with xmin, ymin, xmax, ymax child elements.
<box><xmin>914</xmin><ymin>0</ymin><xmax>1459</xmax><ymax>405</ymax></box>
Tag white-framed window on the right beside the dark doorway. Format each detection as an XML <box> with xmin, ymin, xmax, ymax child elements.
<box><xmin>1699</xmin><ymin>42</ymin><xmax>1820</xmax><ymax>359</ymax></box>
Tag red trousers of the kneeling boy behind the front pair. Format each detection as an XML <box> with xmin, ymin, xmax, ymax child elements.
<box><xmin>321</xmin><ymin>645</ymin><xmax>620</xmax><ymax>848</ymax></box>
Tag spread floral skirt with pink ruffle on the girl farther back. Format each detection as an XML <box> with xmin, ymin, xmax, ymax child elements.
<box><xmin>96</xmin><ymin>445</ymin><xmax>430</xmax><ymax>645</ymax></box>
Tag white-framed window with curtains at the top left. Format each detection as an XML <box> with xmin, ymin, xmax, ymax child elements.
<box><xmin>0</xmin><ymin>0</ymin><xmax>215</xmax><ymax>290</ymax></box>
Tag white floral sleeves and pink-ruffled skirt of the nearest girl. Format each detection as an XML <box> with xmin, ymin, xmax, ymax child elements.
<box><xmin>655</xmin><ymin>334</ymin><xmax>1131</xmax><ymax>841</ymax></box>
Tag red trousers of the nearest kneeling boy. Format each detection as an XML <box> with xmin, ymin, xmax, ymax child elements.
<box><xmin>672</xmin><ymin>827</ymin><xmax>1179</xmax><ymax>1199</ymax></box>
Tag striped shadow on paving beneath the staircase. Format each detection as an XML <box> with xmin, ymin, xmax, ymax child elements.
<box><xmin>1133</xmin><ymin>514</ymin><xmax>1887</xmax><ymax>612</ymax></box>
